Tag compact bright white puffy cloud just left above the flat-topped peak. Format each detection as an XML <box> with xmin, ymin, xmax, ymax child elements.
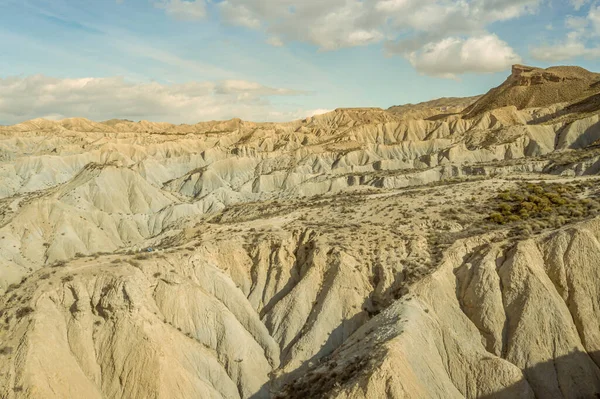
<box><xmin>409</xmin><ymin>35</ymin><xmax>521</xmax><ymax>78</ymax></box>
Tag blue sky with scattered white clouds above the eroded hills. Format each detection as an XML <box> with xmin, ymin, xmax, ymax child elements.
<box><xmin>0</xmin><ymin>0</ymin><xmax>600</xmax><ymax>125</ymax></box>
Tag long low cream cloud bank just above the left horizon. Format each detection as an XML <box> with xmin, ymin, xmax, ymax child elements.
<box><xmin>0</xmin><ymin>75</ymin><xmax>309</xmax><ymax>124</ymax></box>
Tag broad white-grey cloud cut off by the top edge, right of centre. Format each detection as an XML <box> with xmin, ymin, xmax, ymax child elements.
<box><xmin>157</xmin><ymin>0</ymin><xmax>543</xmax><ymax>74</ymax></box>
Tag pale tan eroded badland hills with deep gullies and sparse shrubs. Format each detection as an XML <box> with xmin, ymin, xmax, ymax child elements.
<box><xmin>0</xmin><ymin>67</ymin><xmax>600</xmax><ymax>398</ymax></box>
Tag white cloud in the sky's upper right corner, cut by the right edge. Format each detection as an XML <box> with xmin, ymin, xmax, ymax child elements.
<box><xmin>531</xmin><ymin>1</ymin><xmax>600</xmax><ymax>62</ymax></box>
